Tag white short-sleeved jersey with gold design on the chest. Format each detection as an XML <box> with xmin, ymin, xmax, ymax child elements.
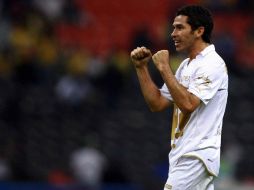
<box><xmin>160</xmin><ymin>45</ymin><xmax>228</xmax><ymax>176</ymax></box>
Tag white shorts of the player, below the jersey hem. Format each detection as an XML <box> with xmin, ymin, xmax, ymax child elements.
<box><xmin>164</xmin><ymin>157</ymin><xmax>214</xmax><ymax>190</ymax></box>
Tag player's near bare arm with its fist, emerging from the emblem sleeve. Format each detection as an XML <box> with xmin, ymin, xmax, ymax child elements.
<box><xmin>152</xmin><ymin>50</ymin><xmax>201</xmax><ymax>114</ymax></box>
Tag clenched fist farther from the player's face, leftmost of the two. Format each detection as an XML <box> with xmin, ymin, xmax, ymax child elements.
<box><xmin>130</xmin><ymin>47</ymin><xmax>152</xmax><ymax>68</ymax></box>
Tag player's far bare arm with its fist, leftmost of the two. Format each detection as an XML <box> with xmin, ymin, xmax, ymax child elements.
<box><xmin>130</xmin><ymin>47</ymin><xmax>171</xmax><ymax>112</ymax></box>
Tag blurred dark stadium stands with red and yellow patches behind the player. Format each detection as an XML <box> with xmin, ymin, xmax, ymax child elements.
<box><xmin>0</xmin><ymin>0</ymin><xmax>254</xmax><ymax>190</ymax></box>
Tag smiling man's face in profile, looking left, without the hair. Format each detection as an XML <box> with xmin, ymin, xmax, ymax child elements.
<box><xmin>171</xmin><ymin>15</ymin><xmax>196</xmax><ymax>52</ymax></box>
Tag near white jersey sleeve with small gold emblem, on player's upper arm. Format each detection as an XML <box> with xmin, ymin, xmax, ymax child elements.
<box><xmin>188</xmin><ymin>65</ymin><xmax>225</xmax><ymax>104</ymax></box>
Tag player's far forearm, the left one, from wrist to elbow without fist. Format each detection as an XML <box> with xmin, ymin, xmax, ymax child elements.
<box><xmin>136</xmin><ymin>67</ymin><xmax>169</xmax><ymax>111</ymax></box>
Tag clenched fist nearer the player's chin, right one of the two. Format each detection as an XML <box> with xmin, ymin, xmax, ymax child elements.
<box><xmin>152</xmin><ymin>50</ymin><xmax>169</xmax><ymax>71</ymax></box>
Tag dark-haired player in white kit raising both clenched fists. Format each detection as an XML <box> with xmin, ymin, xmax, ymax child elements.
<box><xmin>130</xmin><ymin>5</ymin><xmax>228</xmax><ymax>190</ymax></box>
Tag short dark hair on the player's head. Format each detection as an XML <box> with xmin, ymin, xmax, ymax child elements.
<box><xmin>176</xmin><ymin>5</ymin><xmax>213</xmax><ymax>43</ymax></box>
